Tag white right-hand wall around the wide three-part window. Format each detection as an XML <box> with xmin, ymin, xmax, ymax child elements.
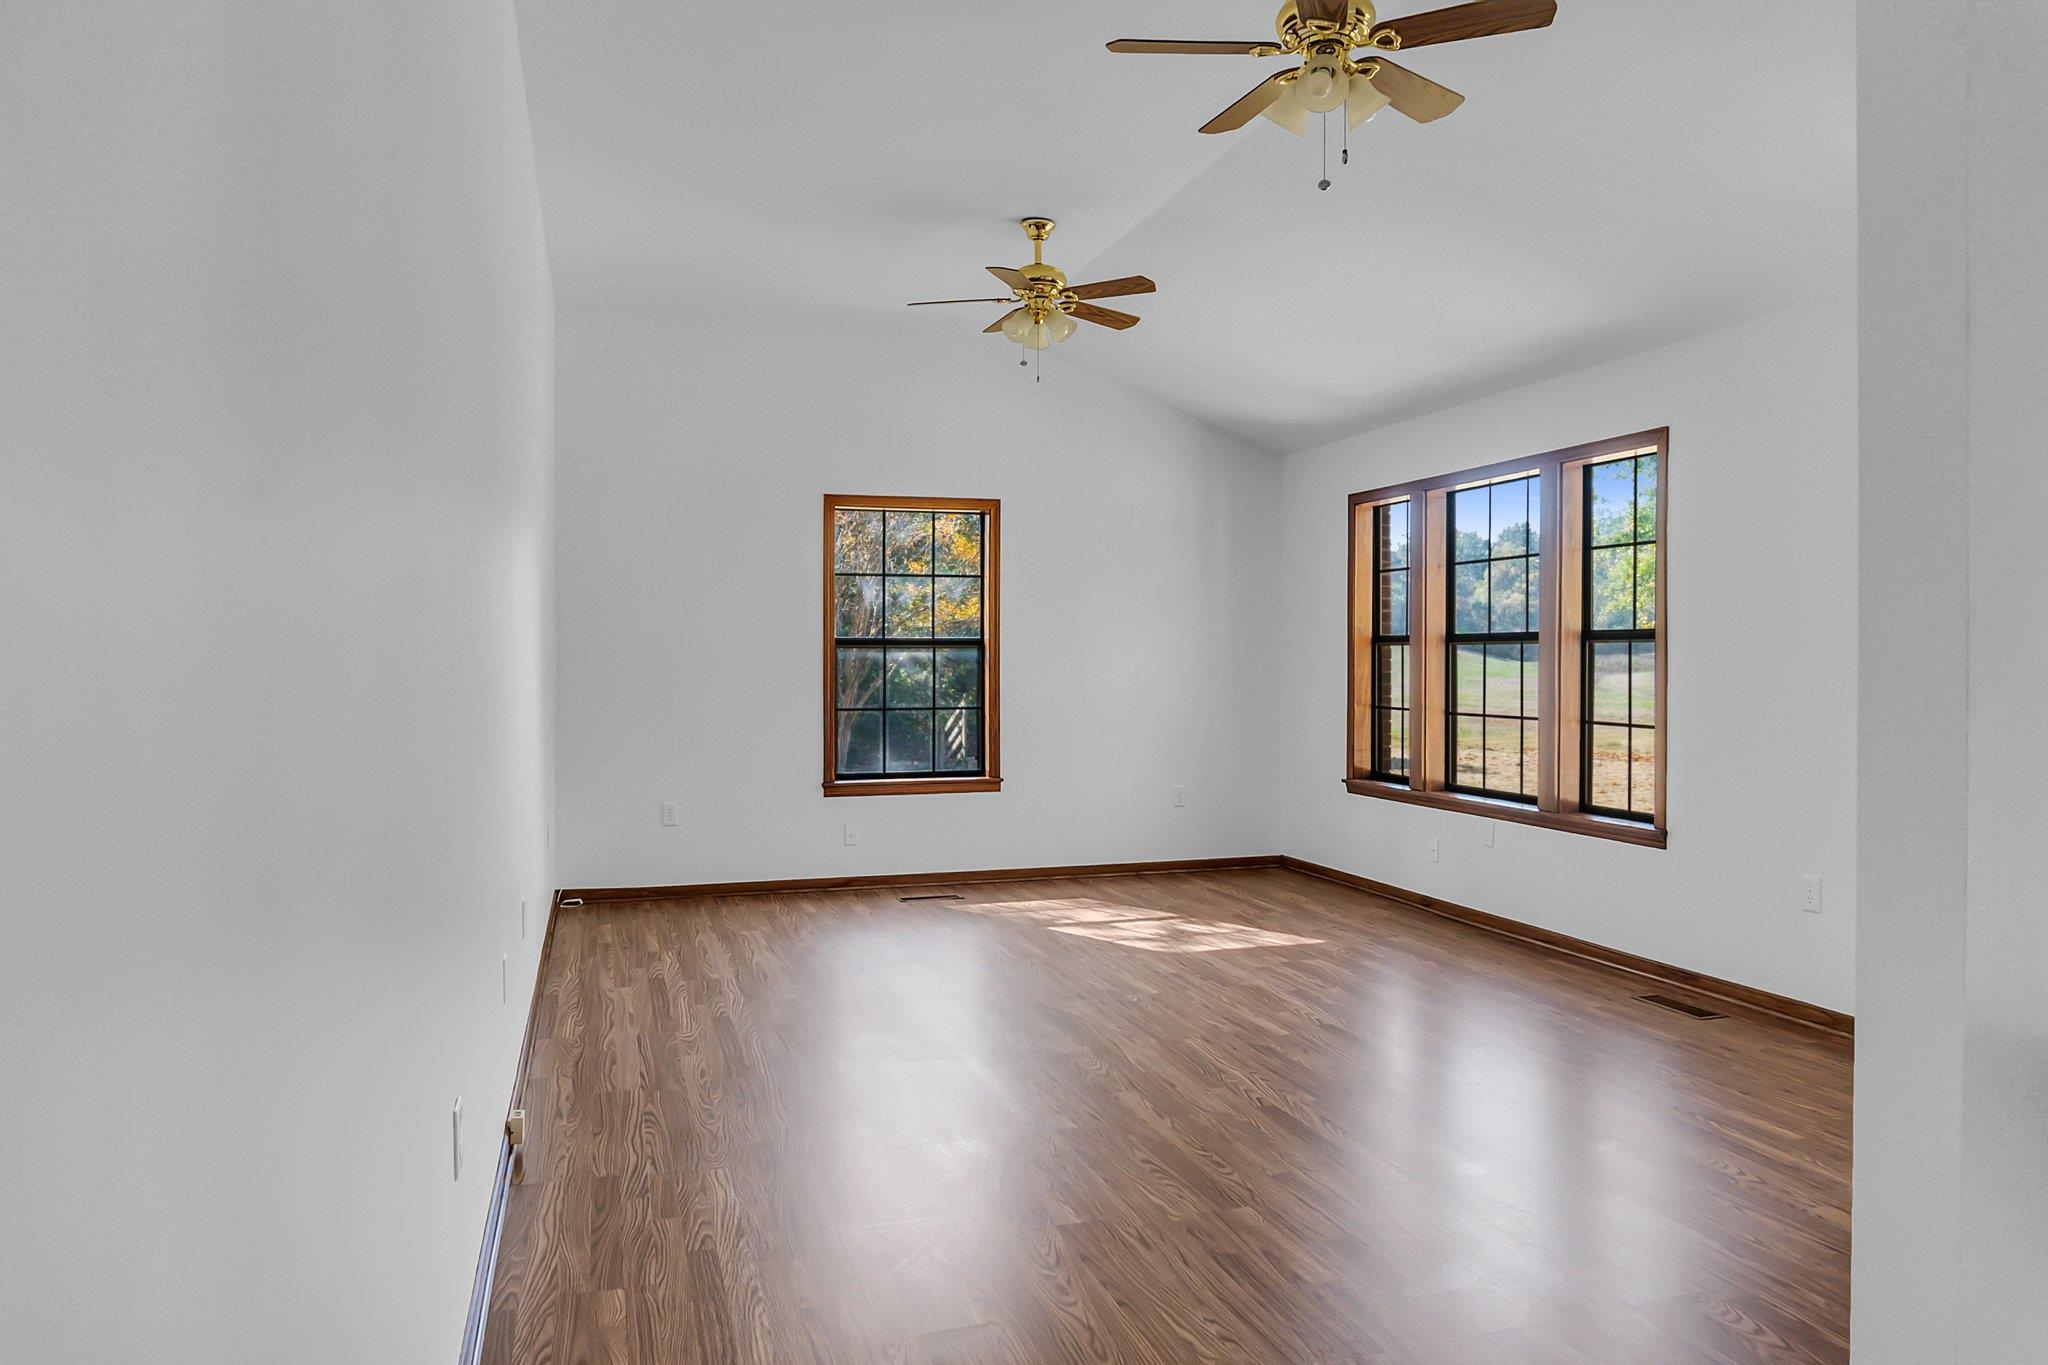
<box><xmin>1280</xmin><ymin>301</ymin><xmax>1858</xmax><ymax>1011</ymax></box>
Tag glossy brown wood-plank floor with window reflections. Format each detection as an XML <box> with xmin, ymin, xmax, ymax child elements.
<box><xmin>485</xmin><ymin>870</ymin><xmax>1849</xmax><ymax>1365</ymax></box>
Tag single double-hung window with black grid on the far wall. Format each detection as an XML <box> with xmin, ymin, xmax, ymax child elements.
<box><xmin>823</xmin><ymin>493</ymin><xmax>1001</xmax><ymax>796</ymax></box>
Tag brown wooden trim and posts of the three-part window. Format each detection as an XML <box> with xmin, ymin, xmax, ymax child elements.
<box><xmin>1343</xmin><ymin>428</ymin><xmax>1671</xmax><ymax>847</ymax></box>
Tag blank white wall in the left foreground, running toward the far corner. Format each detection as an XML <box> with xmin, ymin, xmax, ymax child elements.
<box><xmin>0</xmin><ymin>0</ymin><xmax>551</xmax><ymax>1365</ymax></box>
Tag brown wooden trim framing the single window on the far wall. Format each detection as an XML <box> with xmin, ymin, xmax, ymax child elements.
<box><xmin>819</xmin><ymin>493</ymin><xmax>1004</xmax><ymax>796</ymax></box>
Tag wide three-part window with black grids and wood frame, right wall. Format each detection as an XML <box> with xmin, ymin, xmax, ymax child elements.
<box><xmin>1346</xmin><ymin>430</ymin><xmax>1669</xmax><ymax>845</ymax></box>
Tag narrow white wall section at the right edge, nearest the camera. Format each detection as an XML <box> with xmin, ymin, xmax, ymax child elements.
<box><xmin>1853</xmin><ymin>0</ymin><xmax>2048</xmax><ymax>1365</ymax></box>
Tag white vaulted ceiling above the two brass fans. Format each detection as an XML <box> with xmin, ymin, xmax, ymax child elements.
<box><xmin>518</xmin><ymin>0</ymin><xmax>1855</xmax><ymax>450</ymax></box>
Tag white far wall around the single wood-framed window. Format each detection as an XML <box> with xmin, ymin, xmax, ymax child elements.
<box><xmin>559</xmin><ymin>297</ymin><xmax>1278</xmax><ymax>886</ymax></box>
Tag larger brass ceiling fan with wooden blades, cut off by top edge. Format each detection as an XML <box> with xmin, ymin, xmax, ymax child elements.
<box><xmin>1110</xmin><ymin>0</ymin><xmax>1556</xmax><ymax>140</ymax></box>
